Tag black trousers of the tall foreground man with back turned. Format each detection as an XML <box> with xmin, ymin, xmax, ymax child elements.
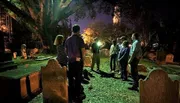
<box><xmin>68</xmin><ymin>62</ymin><xmax>83</xmax><ymax>100</ymax></box>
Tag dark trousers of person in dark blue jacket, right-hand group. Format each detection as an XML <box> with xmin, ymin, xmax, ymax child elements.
<box><xmin>119</xmin><ymin>61</ymin><xmax>128</xmax><ymax>79</ymax></box>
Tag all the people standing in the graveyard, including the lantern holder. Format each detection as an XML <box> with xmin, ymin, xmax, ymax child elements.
<box><xmin>54</xmin><ymin>24</ymin><xmax>141</xmax><ymax>103</ymax></box>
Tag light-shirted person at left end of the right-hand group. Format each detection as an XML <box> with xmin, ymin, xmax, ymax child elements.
<box><xmin>109</xmin><ymin>40</ymin><xmax>118</xmax><ymax>72</ymax></box>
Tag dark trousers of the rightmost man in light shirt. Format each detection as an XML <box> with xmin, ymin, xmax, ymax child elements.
<box><xmin>130</xmin><ymin>58</ymin><xmax>139</xmax><ymax>88</ymax></box>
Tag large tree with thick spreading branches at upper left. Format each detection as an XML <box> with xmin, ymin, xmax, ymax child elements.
<box><xmin>0</xmin><ymin>0</ymin><xmax>101</xmax><ymax>52</ymax></box>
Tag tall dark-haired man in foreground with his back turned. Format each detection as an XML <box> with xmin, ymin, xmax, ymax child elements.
<box><xmin>65</xmin><ymin>24</ymin><xmax>85</xmax><ymax>102</ymax></box>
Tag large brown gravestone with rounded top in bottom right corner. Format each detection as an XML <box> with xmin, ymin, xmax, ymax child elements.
<box><xmin>139</xmin><ymin>69</ymin><xmax>179</xmax><ymax>103</ymax></box>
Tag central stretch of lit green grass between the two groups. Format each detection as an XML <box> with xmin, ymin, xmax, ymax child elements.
<box><xmin>83</xmin><ymin>58</ymin><xmax>139</xmax><ymax>103</ymax></box>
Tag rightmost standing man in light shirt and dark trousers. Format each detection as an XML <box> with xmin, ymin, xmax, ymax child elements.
<box><xmin>128</xmin><ymin>33</ymin><xmax>142</xmax><ymax>90</ymax></box>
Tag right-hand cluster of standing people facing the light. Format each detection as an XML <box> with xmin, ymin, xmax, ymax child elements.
<box><xmin>110</xmin><ymin>33</ymin><xmax>142</xmax><ymax>90</ymax></box>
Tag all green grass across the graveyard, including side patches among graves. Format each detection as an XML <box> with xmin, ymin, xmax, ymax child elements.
<box><xmin>6</xmin><ymin>58</ymin><xmax>179</xmax><ymax>103</ymax></box>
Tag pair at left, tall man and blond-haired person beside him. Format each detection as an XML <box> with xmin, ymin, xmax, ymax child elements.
<box><xmin>54</xmin><ymin>24</ymin><xmax>85</xmax><ymax>103</ymax></box>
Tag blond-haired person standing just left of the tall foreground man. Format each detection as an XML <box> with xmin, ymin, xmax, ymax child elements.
<box><xmin>54</xmin><ymin>35</ymin><xmax>68</xmax><ymax>67</ymax></box>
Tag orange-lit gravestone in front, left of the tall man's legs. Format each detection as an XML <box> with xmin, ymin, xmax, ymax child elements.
<box><xmin>41</xmin><ymin>59</ymin><xmax>68</xmax><ymax>103</ymax></box>
